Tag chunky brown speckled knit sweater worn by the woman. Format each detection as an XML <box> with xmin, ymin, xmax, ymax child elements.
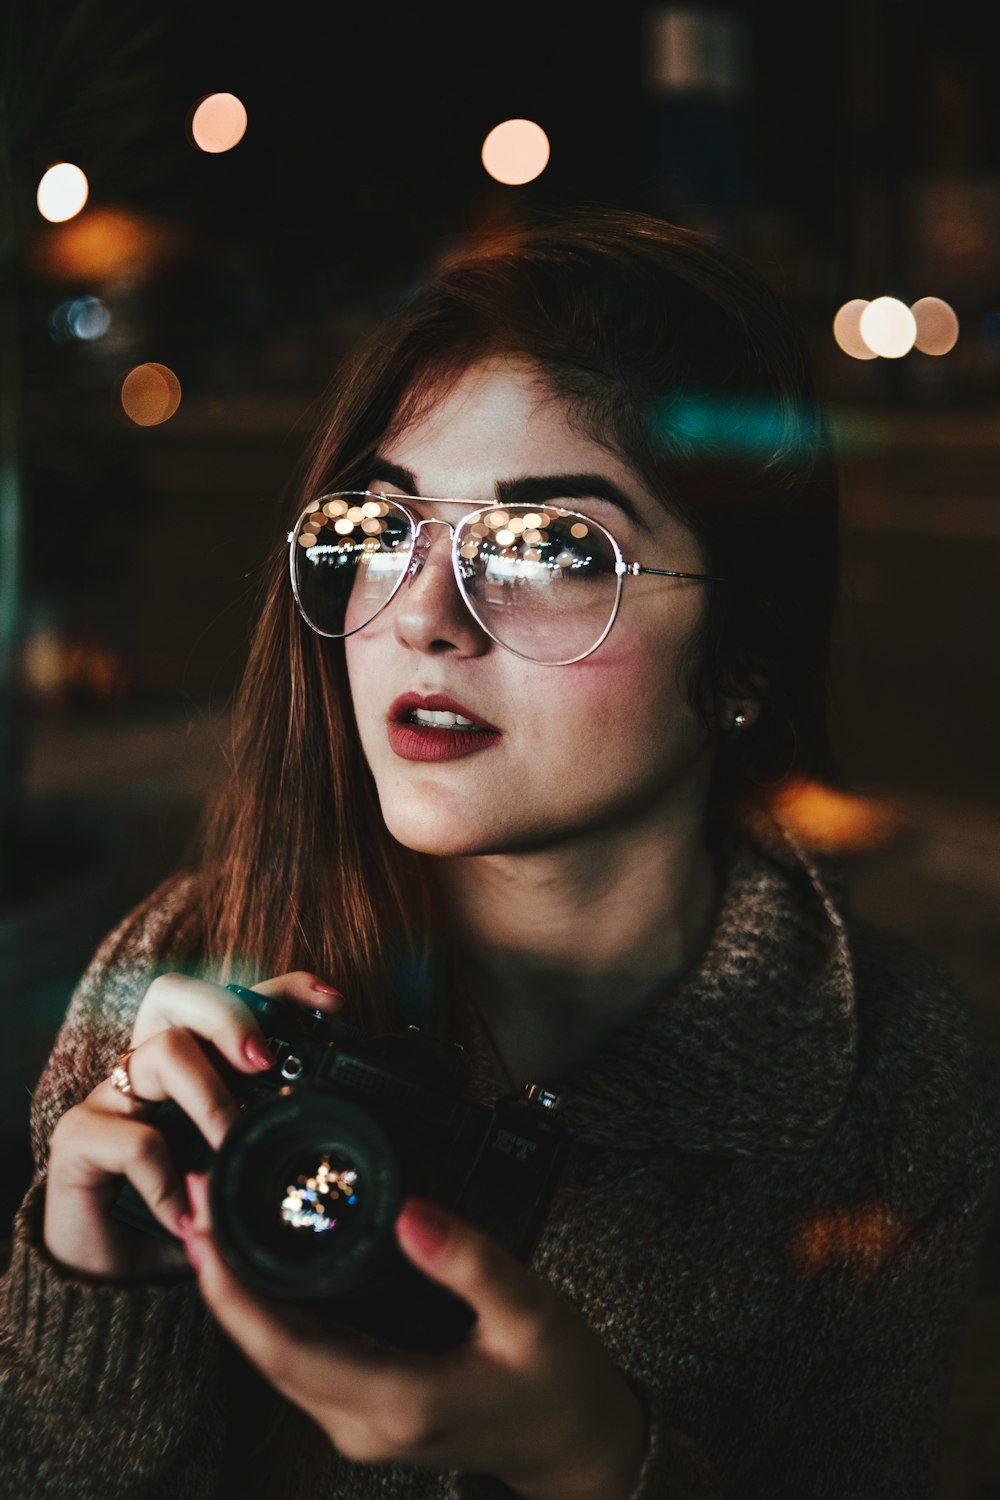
<box><xmin>0</xmin><ymin>827</ymin><xmax>1000</xmax><ymax>1500</ymax></box>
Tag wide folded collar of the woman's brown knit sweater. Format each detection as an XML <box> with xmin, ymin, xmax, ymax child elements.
<box><xmin>485</xmin><ymin>815</ymin><xmax>856</xmax><ymax>1157</ymax></box>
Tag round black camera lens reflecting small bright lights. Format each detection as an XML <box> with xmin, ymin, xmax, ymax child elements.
<box><xmin>210</xmin><ymin>1092</ymin><xmax>402</xmax><ymax>1301</ymax></box>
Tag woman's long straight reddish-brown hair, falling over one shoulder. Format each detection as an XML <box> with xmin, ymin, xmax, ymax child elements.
<box><xmin>179</xmin><ymin>206</ymin><xmax>837</xmax><ymax>1029</ymax></box>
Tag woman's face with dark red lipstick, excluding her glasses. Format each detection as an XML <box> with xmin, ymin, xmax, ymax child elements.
<box><xmin>345</xmin><ymin>357</ymin><xmax>712</xmax><ymax>855</ymax></box>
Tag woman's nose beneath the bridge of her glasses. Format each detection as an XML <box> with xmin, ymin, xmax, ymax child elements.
<box><xmin>393</xmin><ymin>522</ymin><xmax>492</xmax><ymax>656</ymax></box>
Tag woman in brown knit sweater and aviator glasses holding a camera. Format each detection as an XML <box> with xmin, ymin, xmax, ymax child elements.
<box><xmin>1</xmin><ymin>206</ymin><xmax>1000</xmax><ymax>1500</ymax></box>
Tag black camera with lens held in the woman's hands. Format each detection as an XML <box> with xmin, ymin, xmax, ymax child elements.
<box><xmin>111</xmin><ymin>984</ymin><xmax>573</xmax><ymax>1352</ymax></box>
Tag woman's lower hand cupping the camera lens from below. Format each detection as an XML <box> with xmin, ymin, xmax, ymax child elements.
<box><xmin>184</xmin><ymin>1175</ymin><xmax>646</xmax><ymax>1500</ymax></box>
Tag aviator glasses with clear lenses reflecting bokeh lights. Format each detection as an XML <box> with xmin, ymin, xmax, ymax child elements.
<box><xmin>288</xmin><ymin>491</ymin><xmax>727</xmax><ymax>666</ymax></box>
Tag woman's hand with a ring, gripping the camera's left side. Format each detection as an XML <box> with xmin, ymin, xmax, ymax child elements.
<box><xmin>43</xmin><ymin>974</ymin><xmax>342</xmax><ymax>1280</ymax></box>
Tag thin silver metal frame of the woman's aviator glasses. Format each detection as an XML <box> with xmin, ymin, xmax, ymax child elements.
<box><xmin>288</xmin><ymin>489</ymin><xmax>729</xmax><ymax>666</ymax></box>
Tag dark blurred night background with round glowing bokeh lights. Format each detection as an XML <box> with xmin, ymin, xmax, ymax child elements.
<box><xmin>0</xmin><ymin>0</ymin><xmax>1000</xmax><ymax>1496</ymax></box>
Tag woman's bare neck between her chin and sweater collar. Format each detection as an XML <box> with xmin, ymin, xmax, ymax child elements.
<box><xmin>438</xmin><ymin>809</ymin><xmax>718</xmax><ymax>1082</ymax></box>
